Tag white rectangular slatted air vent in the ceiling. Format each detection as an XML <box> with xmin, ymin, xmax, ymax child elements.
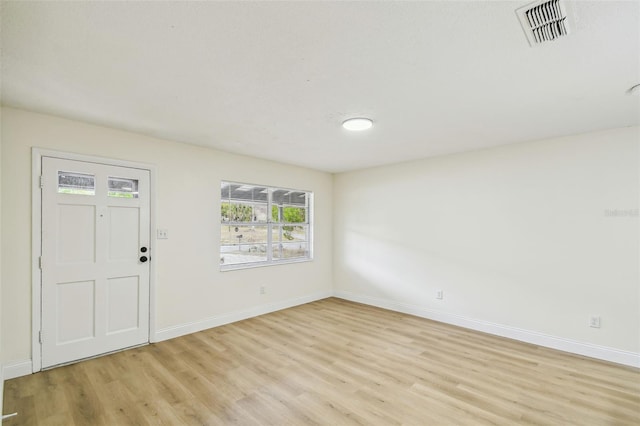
<box><xmin>516</xmin><ymin>0</ymin><xmax>569</xmax><ymax>46</ymax></box>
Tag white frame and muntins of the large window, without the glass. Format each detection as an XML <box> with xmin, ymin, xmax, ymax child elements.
<box><xmin>218</xmin><ymin>180</ymin><xmax>313</xmax><ymax>272</ymax></box>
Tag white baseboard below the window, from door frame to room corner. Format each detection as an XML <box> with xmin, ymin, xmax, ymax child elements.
<box><xmin>153</xmin><ymin>290</ymin><xmax>333</xmax><ymax>342</ymax></box>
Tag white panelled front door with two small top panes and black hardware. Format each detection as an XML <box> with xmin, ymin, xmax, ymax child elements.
<box><xmin>41</xmin><ymin>157</ymin><xmax>150</xmax><ymax>368</ymax></box>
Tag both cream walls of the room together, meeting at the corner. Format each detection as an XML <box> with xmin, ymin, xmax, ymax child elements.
<box><xmin>0</xmin><ymin>108</ymin><xmax>640</xmax><ymax>370</ymax></box>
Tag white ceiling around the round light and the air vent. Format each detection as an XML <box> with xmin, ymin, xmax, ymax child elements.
<box><xmin>1</xmin><ymin>0</ymin><xmax>640</xmax><ymax>172</ymax></box>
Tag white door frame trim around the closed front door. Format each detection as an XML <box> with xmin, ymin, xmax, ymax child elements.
<box><xmin>31</xmin><ymin>147</ymin><xmax>157</xmax><ymax>373</ymax></box>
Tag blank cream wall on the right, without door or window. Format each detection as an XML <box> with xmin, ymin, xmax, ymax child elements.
<box><xmin>334</xmin><ymin>127</ymin><xmax>640</xmax><ymax>366</ymax></box>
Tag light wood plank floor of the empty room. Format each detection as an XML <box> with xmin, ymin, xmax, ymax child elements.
<box><xmin>4</xmin><ymin>298</ymin><xmax>640</xmax><ymax>426</ymax></box>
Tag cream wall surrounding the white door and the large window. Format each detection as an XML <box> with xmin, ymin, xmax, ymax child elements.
<box><xmin>2</xmin><ymin>108</ymin><xmax>332</xmax><ymax>362</ymax></box>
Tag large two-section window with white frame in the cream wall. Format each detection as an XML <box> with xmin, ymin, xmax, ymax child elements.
<box><xmin>220</xmin><ymin>182</ymin><xmax>313</xmax><ymax>270</ymax></box>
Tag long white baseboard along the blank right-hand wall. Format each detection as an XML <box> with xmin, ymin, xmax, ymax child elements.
<box><xmin>333</xmin><ymin>291</ymin><xmax>640</xmax><ymax>368</ymax></box>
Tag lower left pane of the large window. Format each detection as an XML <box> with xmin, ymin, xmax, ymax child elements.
<box><xmin>220</xmin><ymin>225</ymin><xmax>267</xmax><ymax>265</ymax></box>
